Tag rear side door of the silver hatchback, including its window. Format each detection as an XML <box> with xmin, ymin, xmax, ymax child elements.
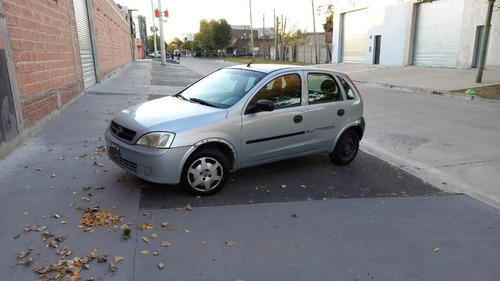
<box><xmin>304</xmin><ymin>72</ymin><xmax>349</xmax><ymax>151</ymax></box>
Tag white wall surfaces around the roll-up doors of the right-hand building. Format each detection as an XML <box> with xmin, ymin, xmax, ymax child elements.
<box><xmin>332</xmin><ymin>0</ymin><xmax>500</xmax><ymax>69</ymax></box>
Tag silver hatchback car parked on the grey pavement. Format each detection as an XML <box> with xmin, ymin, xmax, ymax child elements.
<box><xmin>105</xmin><ymin>64</ymin><xmax>365</xmax><ymax>195</ymax></box>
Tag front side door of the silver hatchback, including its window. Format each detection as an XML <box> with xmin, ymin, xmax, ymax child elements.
<box><xmin>241</xmin><ymin>73</ymin><xmax>306</xmax><ymax>166</ymax></box>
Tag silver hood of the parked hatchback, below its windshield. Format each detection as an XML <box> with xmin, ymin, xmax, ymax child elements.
<box><xmin>113</xmin><ymin>96</ymin><xmax>227</xmax><ymax>135</ymax></box>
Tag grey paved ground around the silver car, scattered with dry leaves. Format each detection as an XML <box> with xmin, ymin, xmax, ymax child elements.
<box><xmin>0</xmin><ymin>57</ymin><xmax>500</xmax><ymax>281</ymax></box>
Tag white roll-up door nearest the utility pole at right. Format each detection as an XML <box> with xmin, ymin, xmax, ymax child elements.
<box><xmin>413</xmin><ymin>0</ymin><xmax>464</xmax><ymax>67</ymax></box>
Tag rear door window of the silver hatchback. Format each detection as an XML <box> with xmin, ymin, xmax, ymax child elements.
<box><xmin>307</xmin><ymin>73</ymin><xmax>343</xmax><ymax>104</ymax></box>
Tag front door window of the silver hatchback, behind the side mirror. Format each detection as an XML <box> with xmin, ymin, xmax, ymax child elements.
<box><xmin>246</xmin><ymin>73</ymin><xmax>302</xmax><ymax>113</ymax></box>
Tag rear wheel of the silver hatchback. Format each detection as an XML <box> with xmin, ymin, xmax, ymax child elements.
<box><xmin>329</xmin><ymin>129</ymin><xmax>359</xmax><ymax>166</ymax></box>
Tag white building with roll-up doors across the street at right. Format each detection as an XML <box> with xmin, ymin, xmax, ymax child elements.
<box><xmin>332</xmin><ymin>0</ymin><xmax>500</xmax><ymax>69</ymax></box>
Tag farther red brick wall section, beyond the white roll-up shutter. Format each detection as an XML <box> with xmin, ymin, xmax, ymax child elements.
<box><xmin>92</xmin><ymin>0</ymin><xmax>132</xmax><ymax>78</ymax></box>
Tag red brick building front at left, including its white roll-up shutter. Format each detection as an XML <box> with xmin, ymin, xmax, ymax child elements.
<box><xmin>0</xmin><ymin>0</ymin><xmax>133</xmax><ymax>157</ymax></box>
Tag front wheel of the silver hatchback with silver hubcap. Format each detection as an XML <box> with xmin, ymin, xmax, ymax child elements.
<box><xmin>181</xmin><ymin>149</ymin><xmax>229</xmax><ymax>196</ymax></box>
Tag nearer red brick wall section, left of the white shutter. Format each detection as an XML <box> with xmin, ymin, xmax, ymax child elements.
<box><xmin>4</xmin><ymin>0</ymin><xmax>83</xmax><ymax>127</ymax></box>
